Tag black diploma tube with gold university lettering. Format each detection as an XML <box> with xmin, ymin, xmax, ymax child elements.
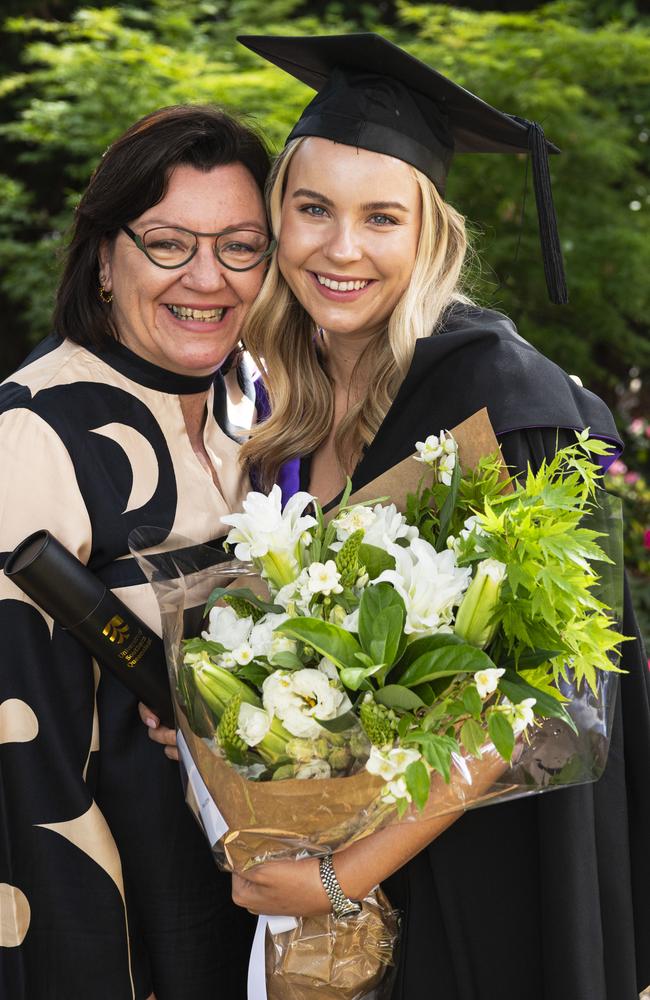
<box><xmin>5</xmin><ymin>531</ymin><xmax>175</xmax><ymax>728</ymax></box>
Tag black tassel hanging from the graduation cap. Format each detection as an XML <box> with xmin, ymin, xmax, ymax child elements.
<box><xmin>513</xmin><ymin>116</ymin><xmax>569</xmax><ymax>305</ymax></box>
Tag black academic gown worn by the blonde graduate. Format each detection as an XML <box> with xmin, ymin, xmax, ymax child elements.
<box><xmin>306</xmin><ymin>306</ymin><xmax>650</xmax><ymax>1000</ymax></box>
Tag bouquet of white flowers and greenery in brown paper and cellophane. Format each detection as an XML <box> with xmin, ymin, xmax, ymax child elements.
<box><xmin>130</xmin><ymin>412</ymin><xmax>623</xmax><ymax>1000</ymax></box>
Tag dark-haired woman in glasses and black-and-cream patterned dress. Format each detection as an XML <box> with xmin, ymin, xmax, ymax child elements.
<box><xmin>0</xmin><ymin>107</ymin><xmax>271</xmax><ymax>1000</ymax></box>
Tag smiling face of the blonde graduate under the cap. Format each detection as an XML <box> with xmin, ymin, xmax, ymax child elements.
<box><xmin>278</xmin><ymin>137</ymin><xmax>421</xmax><ymax>338</ymax></box>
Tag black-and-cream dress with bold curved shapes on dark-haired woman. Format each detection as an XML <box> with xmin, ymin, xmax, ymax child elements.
<box><xmin>0</xmin><ymin>340</ymin><xmax>253</xmax><ymax>1000</ymax></box>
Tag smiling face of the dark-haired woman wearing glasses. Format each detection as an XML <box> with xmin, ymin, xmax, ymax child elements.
<box><xmin>100</xmin><ymin>163</ymin><xmax>267</xmax><ymax>375</ymax></box>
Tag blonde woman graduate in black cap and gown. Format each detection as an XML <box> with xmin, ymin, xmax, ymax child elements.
<box><xmin>227</xmin><ymin>36</ymin><xmax>650</xmax><ymax>1000</ymax></box>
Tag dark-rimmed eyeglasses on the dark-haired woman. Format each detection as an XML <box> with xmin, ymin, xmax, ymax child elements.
<box><xmin>122</xmin><ymin>226</ymin><xmax>275</xmax><ymax>271</ymax></box>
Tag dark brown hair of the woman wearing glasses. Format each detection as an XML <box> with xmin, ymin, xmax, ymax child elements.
<box><xmin>54</xmin><ymin>105</ymin><xmax>269</xmax><ymax>347</ymax></box>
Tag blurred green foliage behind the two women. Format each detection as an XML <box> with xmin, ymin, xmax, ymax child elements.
<box><xmin>0</xmin><ymin>0</ymin><xmax>650</xmax><ymax>635</ymax></box>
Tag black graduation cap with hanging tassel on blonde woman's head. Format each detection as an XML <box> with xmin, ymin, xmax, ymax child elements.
<box><xmin>238</xmin><ymin>32</ymin><xmax>568</xmax><ymax>303</ymax></box>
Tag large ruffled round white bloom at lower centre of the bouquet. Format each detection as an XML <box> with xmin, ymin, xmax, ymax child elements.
<box><xmin>262</xmin><ymin>667</ymin><xmax>351</xmax><ymax>737</ymax></box>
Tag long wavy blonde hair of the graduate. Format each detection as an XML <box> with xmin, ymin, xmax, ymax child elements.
<box><xmin>241</xmin><ymin>138</ymin><xmax>470</xmax><ymax>488</ymax></box>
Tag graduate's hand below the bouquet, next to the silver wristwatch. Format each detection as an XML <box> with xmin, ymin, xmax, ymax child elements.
<box><xmin>232</xmin><ymin>858</ymin><xmax>332</xmax><ymax>917</ymax></box>
